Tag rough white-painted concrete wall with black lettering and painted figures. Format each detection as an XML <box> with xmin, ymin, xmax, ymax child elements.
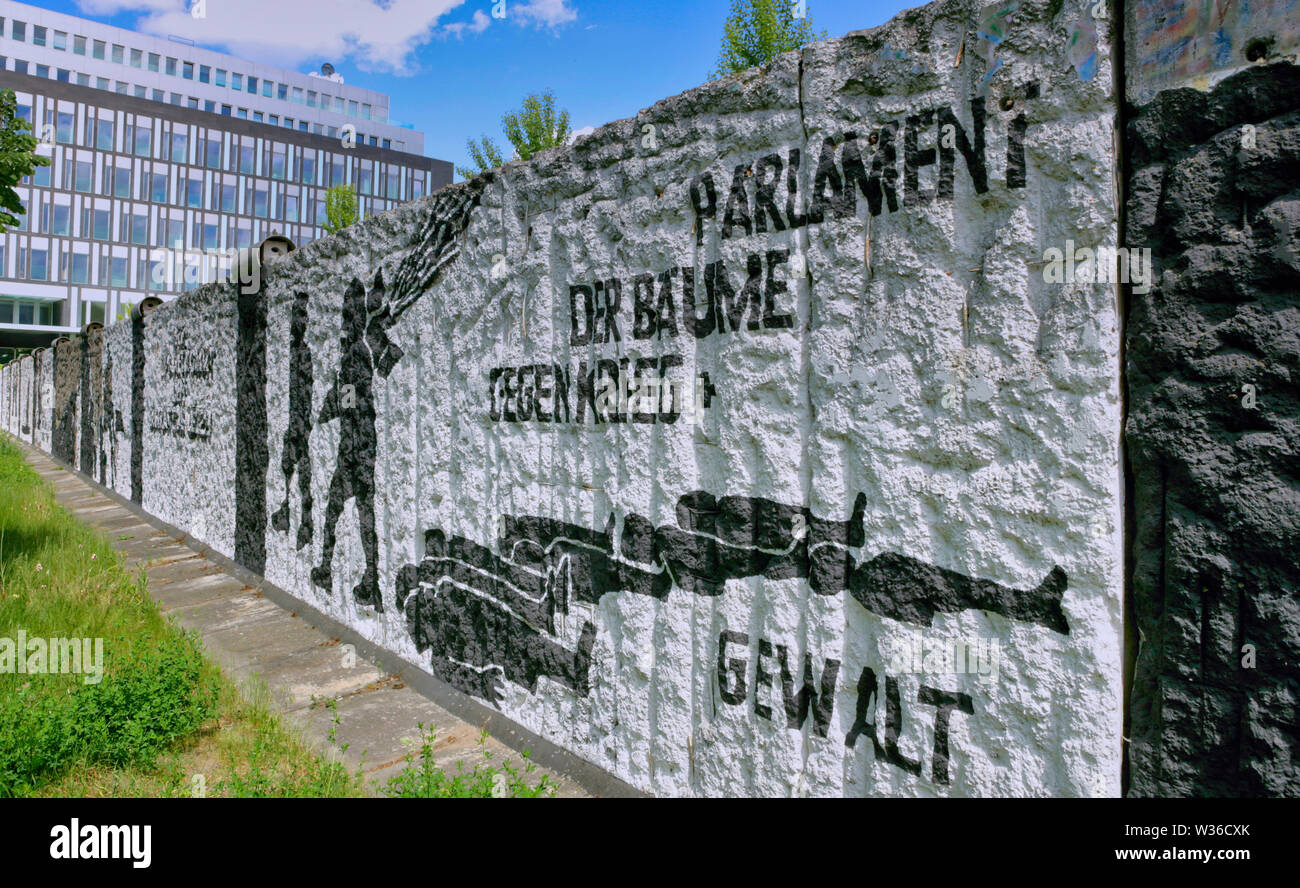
<box><xmin>2</xmin><ymin>1</ymin><xmax>1123</xmax><ymax>796</ymax></box>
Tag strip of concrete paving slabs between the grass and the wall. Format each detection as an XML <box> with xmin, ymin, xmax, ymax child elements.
<box><xmin>16</xmin><ymin>446</ymin><xmax>632</xmax><ymax>797</ymax></box>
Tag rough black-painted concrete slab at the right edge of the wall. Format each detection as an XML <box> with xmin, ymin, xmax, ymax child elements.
<box><xmin>1126</xmin><ymin>65</ymin><xmax>1300</xmax><ymax>796</ymax></box>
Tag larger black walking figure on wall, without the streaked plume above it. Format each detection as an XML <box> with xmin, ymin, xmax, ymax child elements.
<box><xmin>312</xmin><ymin>272</ymin><xmax>402</xmax><ymax>611</ymax></box>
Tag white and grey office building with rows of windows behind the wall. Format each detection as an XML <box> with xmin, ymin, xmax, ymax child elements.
<box><xmin>0</xmin><ymin>0</ymin><xmax>452</xmax><ymax>359</ymax></box>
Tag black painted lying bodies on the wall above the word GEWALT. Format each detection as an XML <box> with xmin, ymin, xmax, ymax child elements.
<box><xmin>397</xmin><ymin>490</ymin><xmax>1070</xmax><ymax>702</ymax></box>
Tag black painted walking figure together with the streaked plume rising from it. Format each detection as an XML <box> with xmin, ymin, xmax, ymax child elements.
<box><xmin>309</xmin><ymin>177</ymin><xmax>491</xmax><ymax>611</ymax></box>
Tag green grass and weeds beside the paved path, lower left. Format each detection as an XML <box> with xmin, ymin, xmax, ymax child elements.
<box><xmin>0</xmin><ymin>436</ymin><xmax>363</xmax><ymax>797</ymax></box>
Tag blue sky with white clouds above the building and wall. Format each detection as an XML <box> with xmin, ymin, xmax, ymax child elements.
<box><xmin>22</xmin><ymin>0</ymin><xmax>920</xmax><ymax>174</ymax></box>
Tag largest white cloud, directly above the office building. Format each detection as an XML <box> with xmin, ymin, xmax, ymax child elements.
<box><xmin>78</xmin><ymin>0</ymin><xmax>470</xmax><ymax>74</ymax></box>
